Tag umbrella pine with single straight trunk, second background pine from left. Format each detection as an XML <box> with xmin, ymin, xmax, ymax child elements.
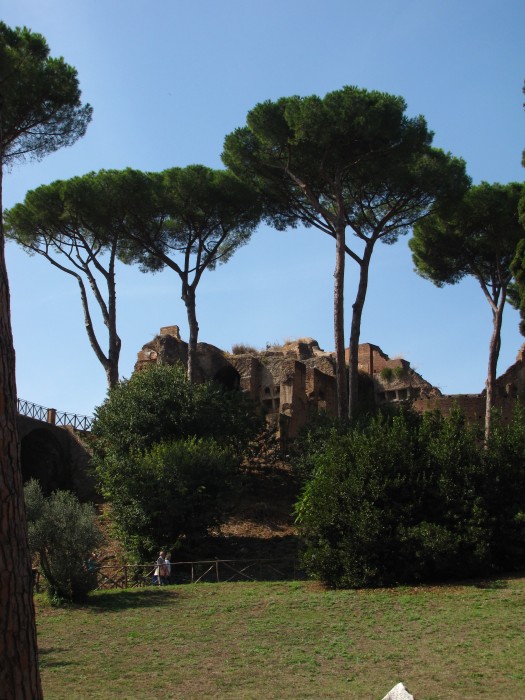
<box><xmin>116</xmin><ymin>165</ymin><xmax>261</xmax><ymax>379</ymax></box>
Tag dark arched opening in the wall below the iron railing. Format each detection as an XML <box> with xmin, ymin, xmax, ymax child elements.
<box><xmin>20</xmin><ymin>428</ymin><xmax>70</xmax><ymax>495</ymax></box>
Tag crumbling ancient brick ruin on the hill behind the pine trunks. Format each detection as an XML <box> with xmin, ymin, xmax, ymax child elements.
<box><xmin>135</xmin><ymin>326</ymin><xmax>525</xmax><ymax>438</ymax></box>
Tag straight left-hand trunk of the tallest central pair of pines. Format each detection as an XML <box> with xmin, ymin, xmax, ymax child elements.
<box><xmin>334</xmin><ymin>223</ymin><xmax>348</xmax><ymax>418</ymax></box>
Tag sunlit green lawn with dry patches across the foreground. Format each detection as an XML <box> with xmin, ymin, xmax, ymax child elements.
<box><xmin>36</xmin><ymin>578</ymin><xmax>525</xmax><ymax>700</ymax></box>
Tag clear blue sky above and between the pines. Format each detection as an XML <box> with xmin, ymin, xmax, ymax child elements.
<box><xmin>0</xmin><ymin>0</ymin><xmax>525</xmax><ymax>414</ymax></box>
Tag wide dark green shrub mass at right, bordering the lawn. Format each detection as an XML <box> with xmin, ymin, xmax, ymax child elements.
<box><xmin>296</xmin><ymin>411</ymin><xmax>525</xmax><ymax>587</ymax></box>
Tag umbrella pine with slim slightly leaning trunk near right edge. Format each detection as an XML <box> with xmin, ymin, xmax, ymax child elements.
<box><xmin>409</xmin><ymin>182</ymin><xmax>525</xmax><ymax>437</ymax></box>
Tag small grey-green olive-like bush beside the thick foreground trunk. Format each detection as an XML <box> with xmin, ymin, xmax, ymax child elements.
<box><xmin>24</xmin><ymin>480</ymin><xmax>102</xmax><ymax>602</ymax></box>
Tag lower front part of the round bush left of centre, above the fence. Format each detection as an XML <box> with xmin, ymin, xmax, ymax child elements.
<box><xmin>98</xmin><ymin>437</ymin><xmax>239</xmax><ymax>559</ymax></box>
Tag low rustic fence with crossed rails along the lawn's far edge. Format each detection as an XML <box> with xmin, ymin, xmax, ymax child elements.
<box><xmin>96</xmin><ymin>559</ymin><xmax>306</xmax><ymax>590</ymax></box>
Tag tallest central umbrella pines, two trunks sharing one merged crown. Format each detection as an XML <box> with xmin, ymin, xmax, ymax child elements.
<box><xmin>222</xmin><ymin>87</ymin><xmax>468</xmax><ymax>417</ymax></box>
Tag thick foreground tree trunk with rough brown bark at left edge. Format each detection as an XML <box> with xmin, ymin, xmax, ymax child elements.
<box><xmin>0</xmin><ymin>110</ymin><xmax>42</xmax><ymax>700</ymax></box>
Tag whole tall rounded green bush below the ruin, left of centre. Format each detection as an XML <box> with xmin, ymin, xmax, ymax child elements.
<box><xmin>92</xmin><ymin>365</ymin><xmax>263</xmax><ymax>558</ymax></box>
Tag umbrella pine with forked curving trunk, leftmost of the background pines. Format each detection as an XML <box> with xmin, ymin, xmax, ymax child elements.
<box><xmin>4</xmin><ymin>170</ymin><xmax>136</xmax><ymax>386</ymax></box>
